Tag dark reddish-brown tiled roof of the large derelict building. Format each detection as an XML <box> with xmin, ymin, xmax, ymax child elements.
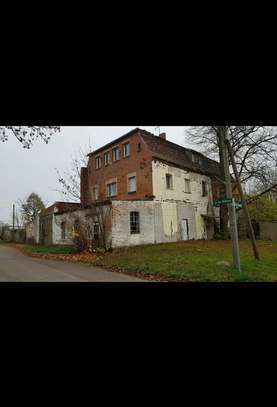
<box><xmin>88</xmin><ymin>127</ymin><xmax>220</xmax><ymax>176</ymax></box>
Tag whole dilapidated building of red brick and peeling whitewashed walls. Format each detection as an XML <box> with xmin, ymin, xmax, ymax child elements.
<box><xmin>33</xmin><ymin>128</ymin><xmax>220</xmax><ymax>247</ymax></box>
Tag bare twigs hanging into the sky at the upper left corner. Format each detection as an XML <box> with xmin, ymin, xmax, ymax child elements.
<box><xmin>0</xmin><ymin>126</ymin><xmax>60</xmax><ymax>149</ymax></box>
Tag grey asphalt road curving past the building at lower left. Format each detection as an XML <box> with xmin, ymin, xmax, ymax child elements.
<box><xmin>0</xmin><ymin>245</ymin><xmax>143</xmax><ymax>283</ymax></box>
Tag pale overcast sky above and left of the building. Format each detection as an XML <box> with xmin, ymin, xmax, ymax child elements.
<box><xmin>0</xmin><ymin>125</ymin><xmax>191</xmax><ymax>224</ymax></box>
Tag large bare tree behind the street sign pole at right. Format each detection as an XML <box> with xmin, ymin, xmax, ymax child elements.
<box><xmin>186</xmin><ymin>126</ymin><xmax>277</xmax><ymax>236</ymax></box>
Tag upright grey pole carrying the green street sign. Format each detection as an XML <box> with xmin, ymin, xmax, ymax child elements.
<box><xmin>220</xmin><ymin>126</ymin><xmax>241</xmax><ymax>271</ymax></box>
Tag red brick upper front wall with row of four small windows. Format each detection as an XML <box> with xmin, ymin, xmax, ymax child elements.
<box><xmin>81</xmin><ymin>130</ymin><xmax>153</xmax><ymax>205</ymax></box>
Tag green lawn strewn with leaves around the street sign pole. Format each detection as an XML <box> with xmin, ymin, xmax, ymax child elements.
<box><xmin>94</xmin><ymin>241</ymin><xmax>277</xmax><ymax>282</ymax></box>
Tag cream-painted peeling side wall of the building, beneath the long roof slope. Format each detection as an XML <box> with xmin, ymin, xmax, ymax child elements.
<box><xmin>152</xmin><ymin>160</ymin><xmax>215</xmax><ymax>239</ymax></box>
